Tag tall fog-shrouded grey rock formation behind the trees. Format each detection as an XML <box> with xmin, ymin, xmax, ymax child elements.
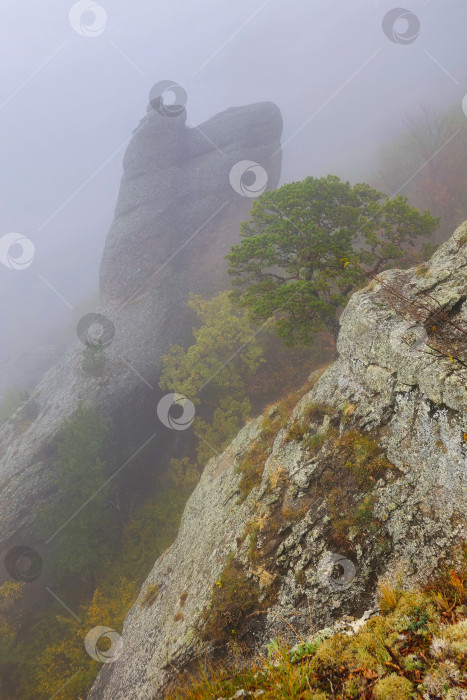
<box><xmin>0</xmin><ymin>103</ymin><xmax>282</xmax><ymax>564</ymax></box>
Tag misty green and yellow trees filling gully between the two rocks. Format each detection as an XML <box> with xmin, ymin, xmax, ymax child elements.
<box><xmin>0</xmin><ymin>293</ymin><xmax>322</xmax><ymax>700</ymax></box>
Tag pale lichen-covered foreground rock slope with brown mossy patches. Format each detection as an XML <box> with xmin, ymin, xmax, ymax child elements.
<box><xmin>89</xmin><ymin>224</ymin><xmax>467</xmax><ymax>700</ymax></box>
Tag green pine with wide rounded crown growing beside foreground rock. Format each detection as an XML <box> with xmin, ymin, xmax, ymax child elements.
<box><xmin>227</xmin><ymin>175</ymin><xmax>439</xmax><ymax>345</ymax></box>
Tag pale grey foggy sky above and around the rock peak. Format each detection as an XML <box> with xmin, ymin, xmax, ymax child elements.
<box><xmin>0</xmin><ymin>0</ymin><xmax>467</xmax><ymax>361</ymax></box>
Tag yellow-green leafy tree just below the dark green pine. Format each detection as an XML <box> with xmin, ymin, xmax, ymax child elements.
<box><xmin>159</xmin><ymin>291</ymin><xmax>318</xmax><ymax>469</ymax></box>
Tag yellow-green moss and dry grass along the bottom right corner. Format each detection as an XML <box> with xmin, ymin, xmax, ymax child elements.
<box><xmin>169</xmin><ymin>549</ymin><xmax>467</xmax><ymax>700</ymax></box>
